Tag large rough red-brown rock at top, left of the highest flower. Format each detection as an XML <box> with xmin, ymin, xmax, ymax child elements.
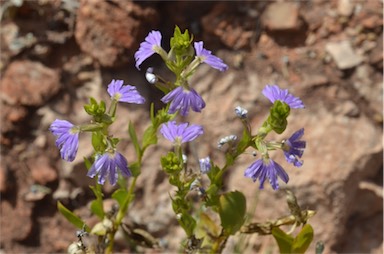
<box><xmin>75</xmin><ymin>0</ymin><xmax>157</xmax><ymax>67</ymax></box>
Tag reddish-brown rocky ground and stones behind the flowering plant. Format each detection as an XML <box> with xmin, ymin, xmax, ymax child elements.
<box><xmin>0</xmin><ymin>0</ymin><xmax>383</xmax><ymax>253</ymax></box>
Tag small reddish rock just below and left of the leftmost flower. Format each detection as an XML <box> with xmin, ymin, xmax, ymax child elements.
<box><xmin>28</xmin><ymin>157</ymin><xmax>58</xmax><ymax>185</ymax></box>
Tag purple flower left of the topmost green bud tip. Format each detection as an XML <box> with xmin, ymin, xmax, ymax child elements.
<box><xmin>135</xmin><ymin>31</ymin><xmax>161</xmax><ymax>70</ymax></box>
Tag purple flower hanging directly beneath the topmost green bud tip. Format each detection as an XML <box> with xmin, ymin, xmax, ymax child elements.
<box><xmin>161</xmin><ymin>86</ymin><xmax>205</xmax><ymax>116</ymax></box>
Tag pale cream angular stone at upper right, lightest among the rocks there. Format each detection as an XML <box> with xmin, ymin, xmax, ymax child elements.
<box><xmin>325</xmin><ymin>41</ymin><xmax>363</xmax><ymax>70</ymax></box>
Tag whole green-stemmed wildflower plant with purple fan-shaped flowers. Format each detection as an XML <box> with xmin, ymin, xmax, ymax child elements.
<box><xmin>50</xmin><ymin>26</ymin><xmax>315</xmax><ymax>253</ymax></box>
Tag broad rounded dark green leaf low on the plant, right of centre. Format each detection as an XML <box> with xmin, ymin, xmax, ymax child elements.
<box><xmin>219</xmin><ymin>191</ymin><xmax>246</xmax><ymax>235</ymax></box>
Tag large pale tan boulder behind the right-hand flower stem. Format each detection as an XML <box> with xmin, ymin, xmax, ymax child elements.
<box><xmin>229</xmin><ymin>105</ymin><xmax>382</xmax><ymax>253</ymax></box>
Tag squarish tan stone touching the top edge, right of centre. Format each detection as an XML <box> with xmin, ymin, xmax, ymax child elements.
<box><xmin>262</xmin><ymin>2</ymin><xmax>301</xmax><ymax>31</ymax></box>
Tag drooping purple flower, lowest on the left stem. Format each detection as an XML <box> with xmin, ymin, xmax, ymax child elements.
<box><xmin>87</xmin><ymin>152</ymin><xmax>132</xmax><ymax>185</ymax></box>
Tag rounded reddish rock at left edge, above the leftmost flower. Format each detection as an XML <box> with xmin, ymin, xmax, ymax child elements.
<box><xmin>0</xmin><ymin>61</ymin><xmax>60</xmax><ymax>106</ymax></box>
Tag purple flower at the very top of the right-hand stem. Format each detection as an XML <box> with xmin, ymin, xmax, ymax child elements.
<box><xmin>263</xmin><ymin>85</ymin><xmax>304</xmax><ymax>108</ymax></box>
